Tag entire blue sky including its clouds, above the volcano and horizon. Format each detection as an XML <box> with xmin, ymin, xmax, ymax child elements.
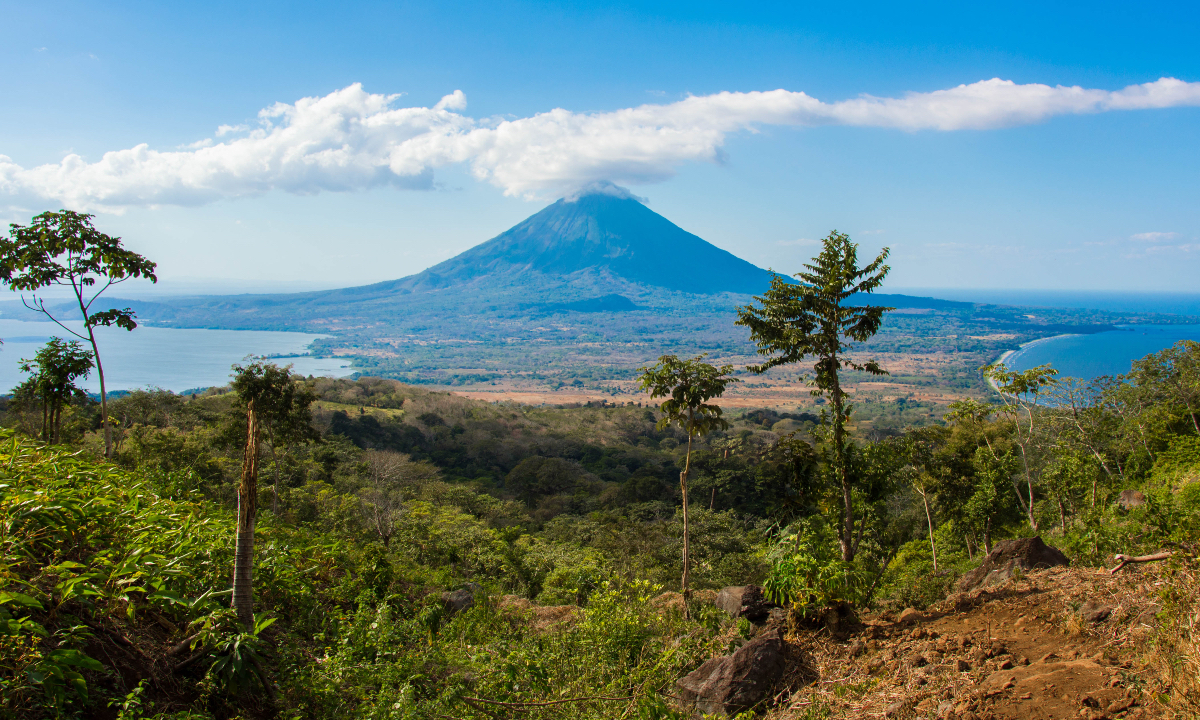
<box><xmin>0</xmin><ymin>2</ymin><xmax>1200</xmax><ymax>292</ymax></box>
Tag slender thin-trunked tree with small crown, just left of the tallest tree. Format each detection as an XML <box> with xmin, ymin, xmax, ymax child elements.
<box><xmin>638</xmin><ymin>355</ymin><xmax>738</xmax><ymax>614</ymax></box>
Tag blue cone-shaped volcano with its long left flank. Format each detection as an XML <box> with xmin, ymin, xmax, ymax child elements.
<box><xmin>131</xmin><ymin>185</ymin><xmax>770</xmax><ymax>330</ymax></box>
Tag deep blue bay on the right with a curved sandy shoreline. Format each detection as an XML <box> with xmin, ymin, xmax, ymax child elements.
<box><xmin>1004</xmin><ymin>325</ymin><xmax>1200</xmax><ymax>379</ymax></box>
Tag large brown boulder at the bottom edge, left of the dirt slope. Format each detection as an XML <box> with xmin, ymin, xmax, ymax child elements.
<box><xmin>676</xmin><ymin>629</ymin><xmax>786</xmax><ymax>716</ymax></box>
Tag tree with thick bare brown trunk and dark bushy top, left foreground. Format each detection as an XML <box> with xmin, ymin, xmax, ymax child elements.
<box><xmin>232</xmin><ymin>360</ymin><xmax>313</xmax><ymax>628</ymax></box>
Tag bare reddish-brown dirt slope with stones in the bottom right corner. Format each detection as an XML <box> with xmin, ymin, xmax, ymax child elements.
<box><xmin>767</xmin><ymin>565</ymin><xmax>1200</xmax><ymax>720</ymax></box>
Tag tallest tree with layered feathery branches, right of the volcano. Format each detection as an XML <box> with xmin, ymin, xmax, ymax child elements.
<box><xmin>737</xmin><ymin>230</ymin><xmax>894</xmax><ymax>563</ymax></box>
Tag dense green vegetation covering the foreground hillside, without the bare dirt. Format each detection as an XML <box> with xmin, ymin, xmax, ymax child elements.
<box><xmin>0</xmin><ymin>343</ymin><xmax>1200</xmax><ymax>719</ymax></box>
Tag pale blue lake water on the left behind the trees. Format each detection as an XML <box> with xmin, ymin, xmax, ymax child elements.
<box><xmin>0</xmin><ymin>319</ymin><xmax>353</xmax><ymax>392</ymax></box>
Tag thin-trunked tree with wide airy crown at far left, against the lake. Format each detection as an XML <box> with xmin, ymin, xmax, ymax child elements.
<box><xmin>0</xmin><ymin>210</ymin><xmax>158</xmax><ymax>457</ymax></box>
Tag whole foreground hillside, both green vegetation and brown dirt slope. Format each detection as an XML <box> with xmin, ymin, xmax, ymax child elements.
<box><xmin>0</xmin><ymin>345</ymin><xmax>1200</xmax><ymax>720</ymax></box>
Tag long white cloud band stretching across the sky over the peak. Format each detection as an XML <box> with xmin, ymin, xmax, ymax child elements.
<box><xmin>0</xmin><ymin>78</ymin><xmax>1200</xmax><ymax>210</ymax></box>
